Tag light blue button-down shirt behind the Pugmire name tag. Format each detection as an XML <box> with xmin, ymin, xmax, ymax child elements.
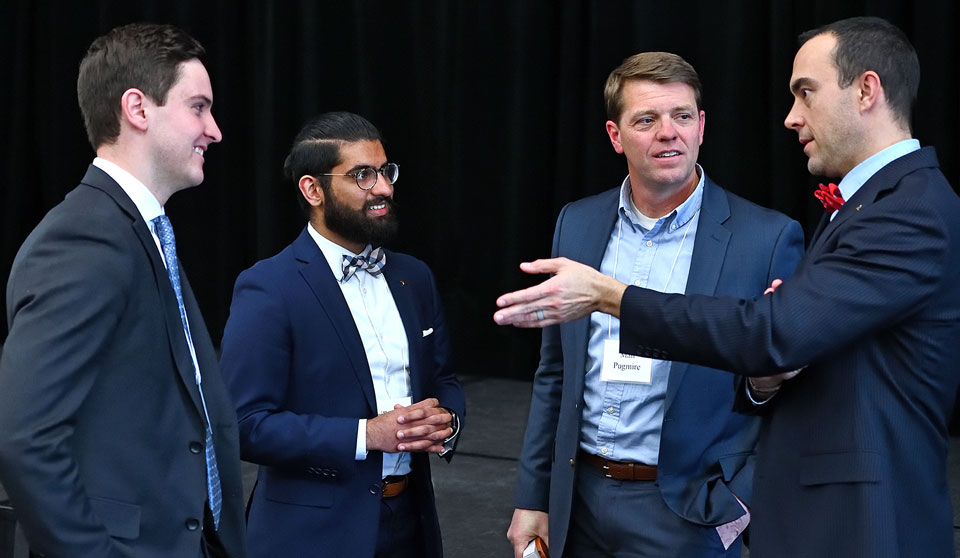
<box><xmin>580</xmin><ymin>165</ymin><xmax>704</xmax><ymax>465</ymax></box>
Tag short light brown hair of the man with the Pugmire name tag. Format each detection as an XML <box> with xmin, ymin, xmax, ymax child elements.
<box><xmin>603</xmin><ymin>52</ymin><xmax>702</xmax><ymax>122</ymax></box>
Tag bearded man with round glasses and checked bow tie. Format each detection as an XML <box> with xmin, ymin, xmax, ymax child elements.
<box><xmin>221</xmin><ymin>112</ymin><xmax>464</xmax><ymax>558</ymax></box>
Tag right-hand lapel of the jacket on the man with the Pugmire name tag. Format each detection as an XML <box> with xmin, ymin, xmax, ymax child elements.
<box><xmin>663</xmin><ymin>182</ymin><xmax>730</xmax><ymax>413</ymax></box>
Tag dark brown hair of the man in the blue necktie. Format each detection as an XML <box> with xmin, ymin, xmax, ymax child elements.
<box><xmin>77</xmin><ymin>23</ymin><xmax>204</xmax><ymax>149</ymax></box>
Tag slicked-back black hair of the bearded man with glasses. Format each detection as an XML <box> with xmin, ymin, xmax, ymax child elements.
<box><xmin>283</xmin><ymin>111</ymin><xmax>381</xmax><ymax>217</ymax></box>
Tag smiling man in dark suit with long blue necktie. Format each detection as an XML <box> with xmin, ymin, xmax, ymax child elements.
<box><xmin>0</xmin><ymin>24</ymin><xmax>244</xmax><ymax>558</ymax></box>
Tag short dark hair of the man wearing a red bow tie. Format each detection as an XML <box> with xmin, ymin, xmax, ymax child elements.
<box><xmin>799</xmin><ymin>17</ymin><xmax>920</xmax><ymax>130</ymax></box>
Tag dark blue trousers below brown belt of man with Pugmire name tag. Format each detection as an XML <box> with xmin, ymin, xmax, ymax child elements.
<box><xmin>563</xmin><ymin>466</ymin><xmax>740</xmax><ymax>558</ymax></box>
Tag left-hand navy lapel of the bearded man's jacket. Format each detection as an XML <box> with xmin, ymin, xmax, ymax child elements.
<box><xmin>293</xmin><ymin>229</ymin><xmax>377</xmax><ymax>413</ymax></box>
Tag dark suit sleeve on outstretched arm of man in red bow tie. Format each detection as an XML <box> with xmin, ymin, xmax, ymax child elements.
<box><xmin>621</xmin><ymin>196</ymin><xmax>950</xmax><ymax>376</ymax></box>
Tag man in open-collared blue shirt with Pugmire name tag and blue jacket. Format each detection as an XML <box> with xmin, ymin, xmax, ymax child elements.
<box><xmin>508</xmin><ymin>52</ymin><xmax>803</xmax><ymax>558</ymax></box>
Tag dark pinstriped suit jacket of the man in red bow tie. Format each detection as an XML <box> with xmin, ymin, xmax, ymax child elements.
<box><xmin>621</xmin><ymin>148</ymin><xmax>960</xmax><ymax>558</ymax></box>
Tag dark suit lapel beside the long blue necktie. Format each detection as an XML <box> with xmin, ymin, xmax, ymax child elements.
<box><xmin>82</xmin><ymin>165</ymin><xmax>203</xmax><ymax>416</ymax></box>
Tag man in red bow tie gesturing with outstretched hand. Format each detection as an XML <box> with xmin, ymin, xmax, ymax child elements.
<box><xmin>495</xmin><ymin>18</ymin><xmax>960</xmax><ymax>558</ymax></box>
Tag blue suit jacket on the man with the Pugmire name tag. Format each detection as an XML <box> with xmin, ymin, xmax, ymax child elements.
<box><xmin>517</xmin><ymin>178</ymin><xmax>803</xmax><ymax>556</ymax></box>
